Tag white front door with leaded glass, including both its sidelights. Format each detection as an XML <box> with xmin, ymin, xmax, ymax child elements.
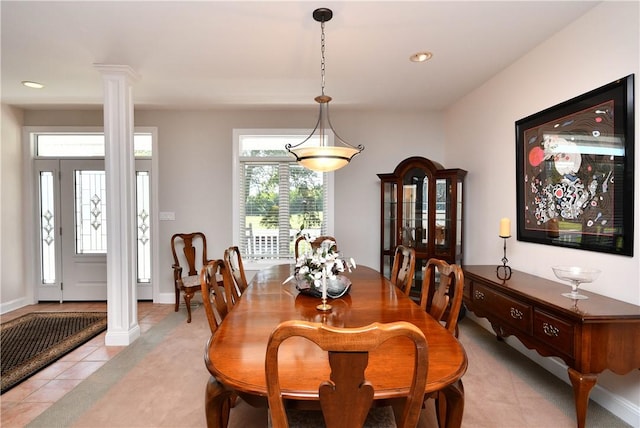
<box><xmin>36</xmin><ymin>159</ymin><xmax>153</xmax><ymax>302</ymax></box>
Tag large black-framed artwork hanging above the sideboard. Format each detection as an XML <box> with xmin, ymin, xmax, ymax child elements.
<box><xmin>515</xmin><ymin>74</ymin><xmax>634</xmax><ymax>256</ymax></box>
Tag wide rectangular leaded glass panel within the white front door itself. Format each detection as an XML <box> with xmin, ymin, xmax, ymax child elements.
<box><xmin>75</xmin><ymin>170</ymin><xmax>107</xmax><ymax>254</ymax></box>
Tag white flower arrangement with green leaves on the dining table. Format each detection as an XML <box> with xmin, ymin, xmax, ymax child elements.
<box><xmin>285</xmin><ymin>235</ymin><xmax>356</xmax><ymax>299</ymax></box>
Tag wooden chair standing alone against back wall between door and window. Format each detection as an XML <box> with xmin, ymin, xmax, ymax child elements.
<box><xmin>171</xmin><ymin>232</ymin><xmax>207</xmax><ymax>323</ymax></box>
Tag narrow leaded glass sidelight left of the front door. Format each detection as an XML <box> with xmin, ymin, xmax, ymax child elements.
<box><xmin>40</xmin><ymin>171</ymin><xmax>56</xmax><ymax>284</ymax></box>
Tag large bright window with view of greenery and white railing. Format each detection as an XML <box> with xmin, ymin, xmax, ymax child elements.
<box><xmin>233</xmin><ymin>130</ymin><xmax>333</xmax><ymax>263</ymax></box>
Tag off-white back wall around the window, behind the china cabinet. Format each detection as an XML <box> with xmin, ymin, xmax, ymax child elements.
<box><xmin>25</xmin><ymin>106</ymin><xmax>444</xmax><ymax>300</ymax></box>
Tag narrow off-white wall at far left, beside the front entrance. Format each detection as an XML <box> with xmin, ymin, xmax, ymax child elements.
<box><xmin>0</xmin><ymin>105</ymin><xmax>28</xmax><ymax>310</ymax></box>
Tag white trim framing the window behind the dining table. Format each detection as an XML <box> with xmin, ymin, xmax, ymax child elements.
<box><xmin>231</xmin><ymin>128</ymin><xmax>334</xmax><ymax>271</ymax></box>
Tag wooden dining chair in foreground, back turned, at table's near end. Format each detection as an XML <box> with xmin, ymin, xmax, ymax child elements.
<box><xmin>265</xmin><ymin>320</ymin><xmax>429</xmax><ymax>428</ymax></box>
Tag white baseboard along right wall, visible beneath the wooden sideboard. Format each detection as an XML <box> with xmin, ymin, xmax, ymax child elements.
<box><xmin>467</xmin><ymin>312</ymin><xmax>640</xmax><ymax>427</ymax></box>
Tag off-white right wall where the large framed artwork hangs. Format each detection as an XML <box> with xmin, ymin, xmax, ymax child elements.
<box><xmin>446</xmin><ymin>2</ymin><xmax>640</xmax><ymax>426</ymax></box>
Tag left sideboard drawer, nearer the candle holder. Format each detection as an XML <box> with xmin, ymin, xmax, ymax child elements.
<box><xmin>472</xmin><ymin>283</ymin><xmax>533</xmax><ymax>334</ymax></box>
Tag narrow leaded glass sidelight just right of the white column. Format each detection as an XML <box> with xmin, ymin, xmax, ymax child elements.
<box><xmin>136</xmin><ymin>171</ymin><xmax>151</xmax><ymax>283</ymax></box>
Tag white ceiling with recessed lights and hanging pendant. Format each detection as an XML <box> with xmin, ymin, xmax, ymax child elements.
<box><xmin>0</xmin><ymin>0</ymin><xmax>598</xmax><ymax>109</ymax></box>
